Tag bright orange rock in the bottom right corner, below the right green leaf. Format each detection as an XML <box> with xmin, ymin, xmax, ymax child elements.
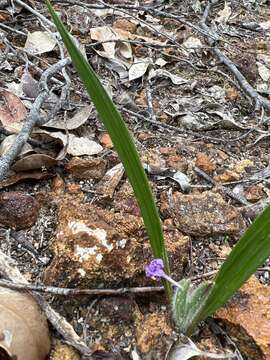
<box><xmin>215</xmin><ymin>276</ymin><xmax>270</xmax><ymax>360</ymax></box>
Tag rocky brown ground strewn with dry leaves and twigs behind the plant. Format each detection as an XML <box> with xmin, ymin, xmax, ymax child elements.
<box><xmin>0</xmin><ymin>0</ymin><xmax>270</xmax><ymax>360</ymax></box>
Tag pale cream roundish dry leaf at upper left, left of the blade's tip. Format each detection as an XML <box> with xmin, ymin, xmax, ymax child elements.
<box><xmin>24</xmin><ymin>31</ymin><xmax>56</xmax><ymax>55</ymax></box>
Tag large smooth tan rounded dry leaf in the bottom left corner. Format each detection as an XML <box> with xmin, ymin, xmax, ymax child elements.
<box><xmin>0</xmin><ymin>288</ymin><xmax>50</xmax><ymax>360</ymax></box>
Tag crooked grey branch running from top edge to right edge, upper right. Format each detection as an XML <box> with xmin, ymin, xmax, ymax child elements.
<box><xmin>200</xmin><ymin>1</ymin><xmax>270</xmax><ymax>111</ymax></box>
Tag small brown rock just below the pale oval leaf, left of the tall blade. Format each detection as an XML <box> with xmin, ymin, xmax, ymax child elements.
<box><xmin>66</xmin><ymin>157</ymin><xmax>107</xmax><ymax>180</ymax></box>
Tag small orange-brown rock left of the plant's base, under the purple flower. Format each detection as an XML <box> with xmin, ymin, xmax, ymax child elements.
<box><xmin>136</xmin><ymin>312</ymin><xmax>172</xmax><ymax>359</ymax></box>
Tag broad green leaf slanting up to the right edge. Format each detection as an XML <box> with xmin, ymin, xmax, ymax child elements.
<box><xmin>197</xmin><ymin>207</ymin><xmax>270</xmax><ymax>321</ymax></box>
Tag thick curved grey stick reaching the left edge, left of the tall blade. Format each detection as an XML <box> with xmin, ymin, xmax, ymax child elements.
<box><xmin>0</xmin><ymin>59</ymin><xmax>71</xmax><ymax>180</ymax></box>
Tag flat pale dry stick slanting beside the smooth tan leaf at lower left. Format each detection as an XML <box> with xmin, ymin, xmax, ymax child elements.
<box><xmin>0</xmin><ymin>250</ymin><xmax>92</xmax><ymax>359</ymax></box>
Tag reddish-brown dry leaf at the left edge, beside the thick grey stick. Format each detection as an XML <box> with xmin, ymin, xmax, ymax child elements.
<box><xmin>0</xmin><ymin>89</ymin><xmax>27</xmax><ymax>133</ymax></box>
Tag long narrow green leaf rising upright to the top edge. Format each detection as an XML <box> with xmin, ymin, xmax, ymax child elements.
<box><xmin>46</xmin><ymin>0</ymin><xmax>171</xmax><ymax>297</ymax></box>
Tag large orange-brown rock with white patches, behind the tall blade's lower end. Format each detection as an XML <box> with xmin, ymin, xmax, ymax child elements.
<box><xmin>44</xmin><ymin>191</ymin><xmax>189</xmax><ymax>287</ymax></box>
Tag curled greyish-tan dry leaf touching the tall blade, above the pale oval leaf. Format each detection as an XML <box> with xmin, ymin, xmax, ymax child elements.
<box><xmin>44</xmin><ymin>105</ymin><xmax>93</xmax><ymax>130</ymax></box>
